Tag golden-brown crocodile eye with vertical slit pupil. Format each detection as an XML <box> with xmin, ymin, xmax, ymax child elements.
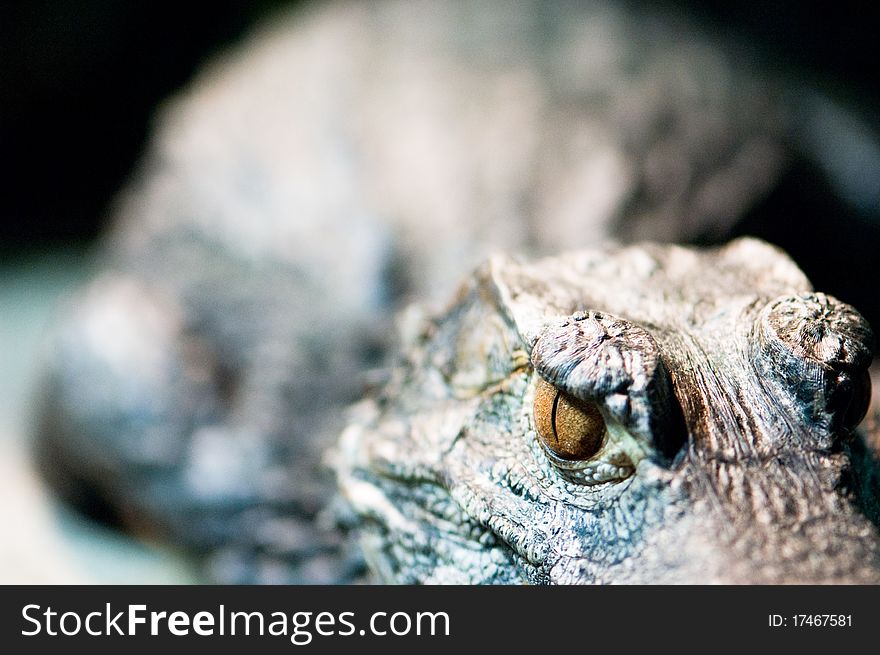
<box><xmin>534</xmin><ymin>378</ymin><xmax>605</xmax><ymax>461</ymax></box>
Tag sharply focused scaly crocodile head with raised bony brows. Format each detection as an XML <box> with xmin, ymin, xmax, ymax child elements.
<box><xmin>332</xmin><ymin>239</ymin><xmax>880</xmax><ymax>584</ymax></box>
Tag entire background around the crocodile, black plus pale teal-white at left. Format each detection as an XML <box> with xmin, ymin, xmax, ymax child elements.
<box><xmin>0</xmin><ymin>0</ymin><xmax>880</xmax><ymax>583</ymax></box>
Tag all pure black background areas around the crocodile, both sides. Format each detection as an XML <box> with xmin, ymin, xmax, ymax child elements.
<box><xmin>0</xmin><ymin>0</ymin><xmax>880</xmax><ymax>322</ymax></box>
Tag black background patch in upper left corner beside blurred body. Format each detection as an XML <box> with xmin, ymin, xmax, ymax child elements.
<box><xmin>0</xmin><ymin>0</ymin><xmax>283</xmax><ymax>252</ymax></box>
